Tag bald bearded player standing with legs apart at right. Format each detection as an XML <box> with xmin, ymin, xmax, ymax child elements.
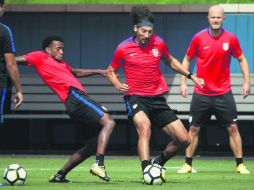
<box><xmin>178</xmin><ymin>5</ymin><xmax>250</xmax><ymax>174</ymax></box>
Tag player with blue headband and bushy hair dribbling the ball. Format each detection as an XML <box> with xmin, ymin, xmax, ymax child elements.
<box><xmin>107</xmin><ymin>6</ymin><xmax>204</xmax><ymax>179</ymax></box>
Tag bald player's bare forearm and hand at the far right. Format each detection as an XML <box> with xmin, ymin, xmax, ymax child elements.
<box><xmin>237</xmin><ymin>54</ymin><xmax>250</xmax><ymax>98</ymax></box>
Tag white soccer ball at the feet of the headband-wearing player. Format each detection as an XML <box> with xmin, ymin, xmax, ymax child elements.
<box><xmin>143</xmin><ymin>164</ymin><xmax>166</xmax><ymax>185</ymax></box>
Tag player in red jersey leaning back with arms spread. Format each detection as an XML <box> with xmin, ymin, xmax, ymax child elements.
<box><xmin>16</xmin><ymin>36</ymin><xmax>115</xmax><ymax>183</ymax></box>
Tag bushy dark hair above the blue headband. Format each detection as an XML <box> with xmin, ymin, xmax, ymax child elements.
<box><xmin>130</xmin><ymin>5</ymin><xmax>154</xmax><ymax>25</ymax></box>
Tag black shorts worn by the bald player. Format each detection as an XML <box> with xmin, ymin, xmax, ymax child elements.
<box><xmin>189</xmin><ymin>91</ymin><xmax>237</xmax><ymax>127</ymax></box>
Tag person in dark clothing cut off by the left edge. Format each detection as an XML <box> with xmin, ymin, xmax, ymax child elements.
<box><xmin>0</xmin><ymin>0</ymin><xmax>24</xmax><ymax>125</ymax></box>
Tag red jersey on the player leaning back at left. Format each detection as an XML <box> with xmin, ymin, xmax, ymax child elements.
<box><xmin>24</xmin><ymin>51</ymin><xmax>86</xmax><ymax>103</ymax></box>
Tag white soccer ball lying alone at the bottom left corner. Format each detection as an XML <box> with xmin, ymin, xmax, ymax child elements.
<box><xmin>4</xmin><ymin>164</ymin><xmax>27</xmax><ymax>185</ymax></box>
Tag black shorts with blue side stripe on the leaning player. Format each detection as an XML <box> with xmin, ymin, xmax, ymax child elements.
<box><xmin>65</xmin><ymin>87</ymin><xmax>108</xmax><ymax>126</ymax></box>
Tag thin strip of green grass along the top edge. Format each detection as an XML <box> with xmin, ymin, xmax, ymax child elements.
<box><xmin>6</xmin><ymin>0</ymin><xmax>254</xmax><ymax>4</ymax></box>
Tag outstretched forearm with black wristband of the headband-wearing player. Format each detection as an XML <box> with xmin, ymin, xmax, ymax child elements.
<box><xmin>165</xmin><ymin>55</ymin><xmax>204</xmax><ymax>88</ymax></box>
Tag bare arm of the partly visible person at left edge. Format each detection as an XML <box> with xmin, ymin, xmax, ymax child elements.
<box><xmin>4</xmin><ymin>53</ymin><xmax>24</xmax><ymax>108</ymax></box>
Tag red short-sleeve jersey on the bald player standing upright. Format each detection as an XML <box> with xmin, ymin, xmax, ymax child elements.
<box><xmin>186</xmin><ymin>29</ymin><xmax>242</xmax><ymax>96</ymax></box>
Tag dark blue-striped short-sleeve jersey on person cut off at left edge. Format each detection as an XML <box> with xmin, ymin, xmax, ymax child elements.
<box><xmin>0</xmin><ymin>23</ymin><xmax>16</xmax><ymax>87</ymax></box>
